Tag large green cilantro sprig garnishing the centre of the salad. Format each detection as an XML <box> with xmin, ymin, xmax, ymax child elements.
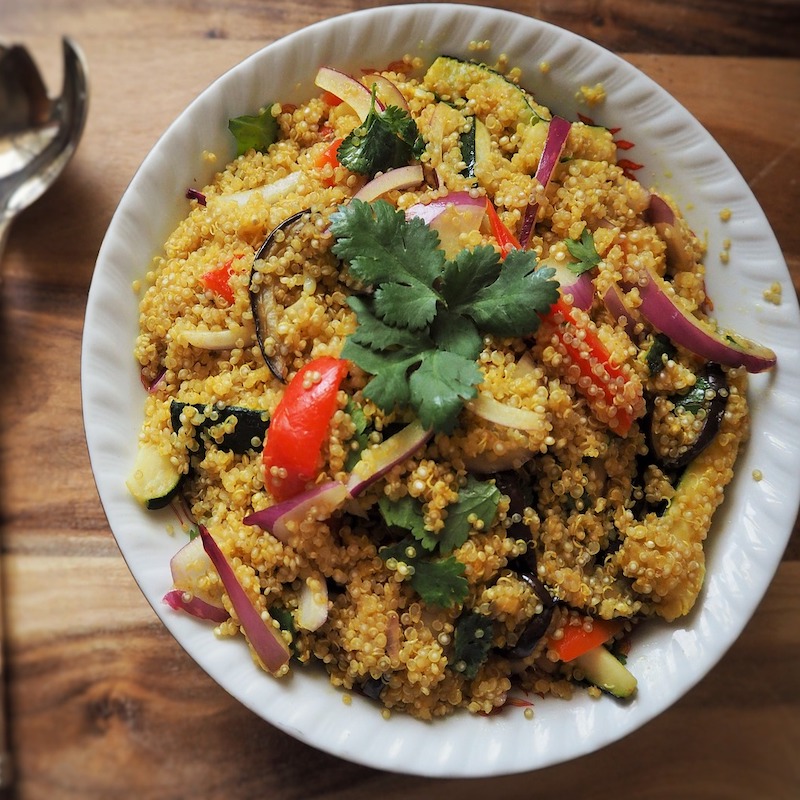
<box><xmin>331</xmin><ymin>200</ymin><xmax>558</xmax><ymax>433</ymax></box>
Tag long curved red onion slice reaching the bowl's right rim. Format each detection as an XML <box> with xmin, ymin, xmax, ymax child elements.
<box><xmin>637</xmin><ymin>267</ymin><xmax>777</xmax><ymax>372</ymax></box>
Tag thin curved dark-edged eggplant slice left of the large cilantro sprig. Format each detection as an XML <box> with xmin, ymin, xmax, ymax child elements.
<box><xmin>250</xmin><ymin>209</ymin><xmax>311</xmax><ymax>382</ymax></box>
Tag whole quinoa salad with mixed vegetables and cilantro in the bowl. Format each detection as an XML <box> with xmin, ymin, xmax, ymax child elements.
<box><xmin>128</xmin><ymin>55</ymin><xmax>776</xmax><ymax>720</ymax></box>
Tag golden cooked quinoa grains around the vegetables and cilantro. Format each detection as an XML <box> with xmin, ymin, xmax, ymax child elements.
<box><xmin>126</xmin><ymin>57</ymin><xmax>776</xmax><ymax>719</ymax></box>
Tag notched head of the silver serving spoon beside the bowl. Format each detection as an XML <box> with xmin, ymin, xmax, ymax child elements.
<box><xmin>0</xmin><ymin>37</ymin><xmax>89</xmax><ymax>253</ymax></box>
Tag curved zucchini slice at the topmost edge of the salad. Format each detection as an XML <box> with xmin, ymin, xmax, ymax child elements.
<box><xmin>423</xmin><ymin>56</ymin><xmax>542</xmax><ymax>123</ymax></box>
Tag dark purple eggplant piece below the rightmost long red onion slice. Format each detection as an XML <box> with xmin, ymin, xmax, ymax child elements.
<box><xmin>649</xmin><ymin>363</ymin><xmax>728</xmax><ymax>471</ymax></box>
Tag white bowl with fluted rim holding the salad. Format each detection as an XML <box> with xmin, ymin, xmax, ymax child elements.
<box><xmin>82</xmin><ymin>4</ymin><xmax>800</xmax><ymax>777</ymax></box>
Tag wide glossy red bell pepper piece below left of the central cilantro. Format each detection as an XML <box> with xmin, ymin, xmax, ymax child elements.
<box><xmin>262</xmin><ymin>356</ymin><xmax>349</xmax><ymax>501</ymax></box>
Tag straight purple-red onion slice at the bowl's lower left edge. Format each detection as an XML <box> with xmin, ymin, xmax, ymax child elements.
<box><xmin>200</xmin><ymin>525</ymin><xmax>291</xmax><ymax>674</ymax></box>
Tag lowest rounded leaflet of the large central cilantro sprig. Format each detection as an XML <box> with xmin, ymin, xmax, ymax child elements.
<box><xmin>409</xmin><ymin>350</ymin><xmax>483</xmax><ymax>433</ymax></box>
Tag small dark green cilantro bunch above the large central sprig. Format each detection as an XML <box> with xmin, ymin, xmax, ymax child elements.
<box><xmin>337</xmin><ymin>87</ymin><xmax>425</xmax><ymax>178</ymax></box>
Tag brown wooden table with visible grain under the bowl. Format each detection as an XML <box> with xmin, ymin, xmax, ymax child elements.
<box><xmin>0</xmin><ymin>0</ymin><xmax>800</xmax><ymax>800</ymax></box>
